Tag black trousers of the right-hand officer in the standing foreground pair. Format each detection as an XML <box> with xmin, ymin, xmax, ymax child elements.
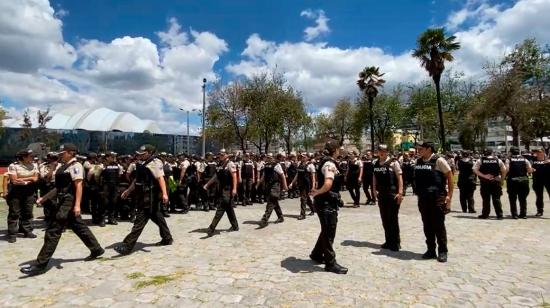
<box><xmin>418</xmin><ymin>195</ymin><xmax>447</xmax><ymax>252</ymax></box>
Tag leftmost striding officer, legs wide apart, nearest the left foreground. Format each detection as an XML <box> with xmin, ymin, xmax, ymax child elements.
<box><xmin>20</xmin><ymin>143</ymin><xmax>105</xmax><ymax>275</ymax></box>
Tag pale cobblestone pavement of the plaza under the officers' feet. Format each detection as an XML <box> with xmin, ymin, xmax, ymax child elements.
<box><xmin>0</xmin><ymin>191</ymin><xmax>550</xmax><ymax>307</ymax></box>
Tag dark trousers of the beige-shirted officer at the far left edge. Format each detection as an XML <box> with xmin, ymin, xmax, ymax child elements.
<box><xmin>7</xmin><ymin>186</ymin><xmax>36</xmax><ymax>237</ymax></box>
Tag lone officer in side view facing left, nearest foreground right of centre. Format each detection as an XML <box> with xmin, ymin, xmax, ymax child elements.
<box><xmin>309</xmin><ymin>140</ymin><xmax>348</xmax><ymax>274</ymax></box>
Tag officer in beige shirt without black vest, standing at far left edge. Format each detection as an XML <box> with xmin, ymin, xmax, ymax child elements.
<box><xmin>6</xmin><ymin>150</ymin><xmax>38</xmax><ymax>243</ymax></box>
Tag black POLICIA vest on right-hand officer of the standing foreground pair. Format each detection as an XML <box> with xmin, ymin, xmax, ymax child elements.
<box><xmin>414</xmin><ymin>155</ymin><xmax>447</xmax><ymax>196</ymax></box>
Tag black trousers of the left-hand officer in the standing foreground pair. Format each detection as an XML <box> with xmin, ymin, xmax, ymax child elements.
<box><xmin>378</xmin><ymin>193</ymin><xmax>401</xmax><ymax>247</ymax></box>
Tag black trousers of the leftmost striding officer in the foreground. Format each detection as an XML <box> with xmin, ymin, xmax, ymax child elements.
<box><xmin>36</xmin><ymin>194</ymin><xmax>101</xmax><ymax>266</ymax></box>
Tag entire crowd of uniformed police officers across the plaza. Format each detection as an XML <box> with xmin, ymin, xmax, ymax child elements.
<box><xmin>3</xmin><ymin>141</ymin><xmax>550</xmax><ymax>275</ymax></box>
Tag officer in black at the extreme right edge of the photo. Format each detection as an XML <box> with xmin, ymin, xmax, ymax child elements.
<box><xmin>533</xmin><ymin>149</ymin><xmax>550</xmax><ymax>217</ymax></box>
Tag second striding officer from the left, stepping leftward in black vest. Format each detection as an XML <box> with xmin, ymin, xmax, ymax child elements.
<box><xmin>115</xmin><ymin>144</ymin><xmax>173</xmax><ymax>255</ymax></box>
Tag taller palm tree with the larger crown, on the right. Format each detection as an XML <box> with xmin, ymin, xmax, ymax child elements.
<box><xmin>413</xmin><ymin>28</ymin><xmax>460</xmax><ymax>150</ymax></box>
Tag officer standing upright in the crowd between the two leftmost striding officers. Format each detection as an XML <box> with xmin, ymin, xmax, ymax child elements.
<box><xmin>99</xmin><ymin>152</ymin><xmax>124</xmax><ymax>226</ymax></box>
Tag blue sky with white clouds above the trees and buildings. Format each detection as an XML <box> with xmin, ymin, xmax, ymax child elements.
<box><xmin>0</xmin><ymin>0</ymin><xmax>550</xmax><ymax>132</ymax></box>
